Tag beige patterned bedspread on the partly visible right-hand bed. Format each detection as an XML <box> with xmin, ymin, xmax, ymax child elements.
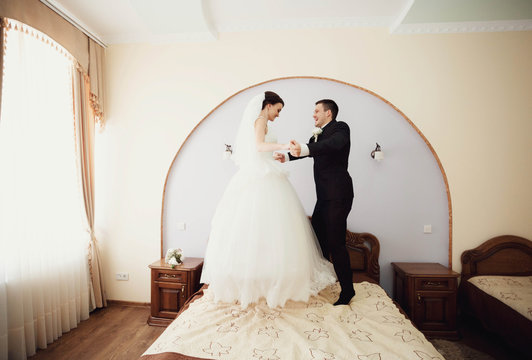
<box><xmin>468</xmin><ymin>275</ymin><xmax>532</xmax><ymax>320</ymax></box>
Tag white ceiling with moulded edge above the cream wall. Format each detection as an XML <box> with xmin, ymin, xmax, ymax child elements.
<box><xmin>41</xmin><ymin>0</ymin><xmax>532</xmax><ymax>45</ymax></box>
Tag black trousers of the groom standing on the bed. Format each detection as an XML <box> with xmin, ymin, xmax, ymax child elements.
<box><xmin>312</xmin><ymin>198</ymin><xmax>354</xmax><ymax>294</ymax></box>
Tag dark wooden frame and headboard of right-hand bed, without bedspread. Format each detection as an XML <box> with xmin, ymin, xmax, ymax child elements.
<box><xmin>458</xmin><ymin>235</ymin><xmax>532</xmax><ymax>353</ymax></box>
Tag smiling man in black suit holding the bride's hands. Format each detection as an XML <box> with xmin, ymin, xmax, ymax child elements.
<box><xmin>275</xmin><ymin>99</ymin><xmax>355</xmax><ymax>305</ymax></box>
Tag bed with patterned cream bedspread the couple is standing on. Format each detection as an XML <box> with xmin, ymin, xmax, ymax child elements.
<box><xmin>141</xmin><ymin>231</ymin><xmax>443</xmax><ymax>360</ymax></box>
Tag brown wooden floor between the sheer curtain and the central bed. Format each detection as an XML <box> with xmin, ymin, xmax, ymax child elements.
<box><xmin>28</xmin><ymin>305</ymin><xmax>165</xmax><ymax>360</ymax></box>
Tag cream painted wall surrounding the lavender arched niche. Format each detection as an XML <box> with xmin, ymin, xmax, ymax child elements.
<box><xmin>96</xmin><ymin>29</ymin><xmax>532</xmax><ymax>302</ymax></box>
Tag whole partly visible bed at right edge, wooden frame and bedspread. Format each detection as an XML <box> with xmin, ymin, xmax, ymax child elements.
<box><xmin>458</xmin><ymin>235</ymin><xmax>532</xmax><ymax>354</ymax></box>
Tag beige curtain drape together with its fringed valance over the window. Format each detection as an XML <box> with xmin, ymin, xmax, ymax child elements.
<box><xmin>0</xmin><ymin>0</ymin><xmax>106</xmax><ymax>309</ymax></box>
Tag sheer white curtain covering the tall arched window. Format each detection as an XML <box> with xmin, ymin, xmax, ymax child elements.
<box><xmin>0</xmin><ymin>22</ymin><xmax>89</xmax><ymax>359</ymax></box>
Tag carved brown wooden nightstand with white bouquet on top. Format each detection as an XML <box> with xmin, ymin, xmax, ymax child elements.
<box><xmin>148</xmin><ymin>258</ymin><xmax>203</xmax><ymax>326</ymax></box>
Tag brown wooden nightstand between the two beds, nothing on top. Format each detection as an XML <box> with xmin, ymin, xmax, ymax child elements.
<box><xmin>392</xmin><ymin>263</ymin><xmax>460</xmax><ymax>339</ymax></box>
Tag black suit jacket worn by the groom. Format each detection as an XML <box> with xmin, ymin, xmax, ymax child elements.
<box><xmin>289</xmin><ymin>120</ymin><xmax>353</xmax><ymax>200</ymax></box>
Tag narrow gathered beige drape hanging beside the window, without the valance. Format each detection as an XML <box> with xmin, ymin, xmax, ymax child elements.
<box><xmin>73</xmin><ymin>67</ymin><xmax>107</xmax><ymax>310</ymax></box>
